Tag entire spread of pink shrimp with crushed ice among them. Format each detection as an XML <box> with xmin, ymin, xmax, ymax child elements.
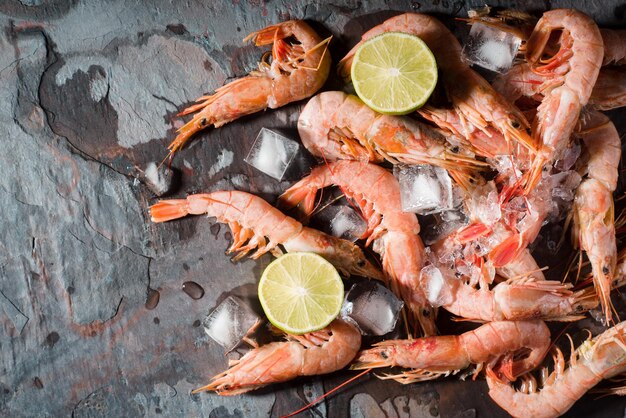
<box><xmin>150</xmin><ymin>9</ymin><xmax>626</xmax><ymax>417</ymax></box>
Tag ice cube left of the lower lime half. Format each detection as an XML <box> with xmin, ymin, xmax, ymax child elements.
<box><xmin>202</xmin><ymin>296</ymin><xmax>261</xmax><ymax>351</ymax></box>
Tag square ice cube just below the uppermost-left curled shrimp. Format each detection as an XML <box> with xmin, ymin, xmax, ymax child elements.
<box><xmin>244</xmin><ymin>128</ymin><xmax>300</xmax><ymax>181</ymax></box>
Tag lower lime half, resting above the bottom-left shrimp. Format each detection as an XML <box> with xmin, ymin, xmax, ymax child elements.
<box><xmin>259</xmin><ymin>252</ymin><xmax>343</xmax><ymax>334</ymax></box>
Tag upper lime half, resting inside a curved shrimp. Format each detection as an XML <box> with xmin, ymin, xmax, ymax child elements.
<box><xmin>351</xmin><ymin>32</ymin><xmax>437</xmax><ymax>115</ymax></box>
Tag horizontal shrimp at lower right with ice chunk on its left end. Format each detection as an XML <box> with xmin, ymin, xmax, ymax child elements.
<box><xmin>419</xmin><ymin>265</ymin><xmax>598</xmax><ymax>321</ymax></box>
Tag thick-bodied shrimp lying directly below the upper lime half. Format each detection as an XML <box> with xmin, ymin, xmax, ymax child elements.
<box><xmin>298</xmin><ymin>91</ymin><xmax>483</xmax><ymax>189</ymax></box>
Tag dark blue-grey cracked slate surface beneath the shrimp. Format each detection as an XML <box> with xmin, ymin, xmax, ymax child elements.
<box><xmin>0</xmin><ymin>0</ymin><xmax>626</xmax><ymax>417</ymax></box>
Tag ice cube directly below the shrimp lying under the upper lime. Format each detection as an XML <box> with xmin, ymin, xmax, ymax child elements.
<box><xmin>393</xmin><ymin>164</ymin><xmax>454</xmax><ymax>215</ymax></box>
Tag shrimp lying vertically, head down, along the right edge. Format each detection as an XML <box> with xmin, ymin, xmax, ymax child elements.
<box><xmin>572</xmin><ymin>112</ymin><xmax>621</xmax><ymax>321</ymax></box>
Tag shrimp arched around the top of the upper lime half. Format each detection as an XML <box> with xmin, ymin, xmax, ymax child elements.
<box><xmin>339</xmin><ymin>13</ymin><xmax>535</xmax><ymax>156</ymax></box>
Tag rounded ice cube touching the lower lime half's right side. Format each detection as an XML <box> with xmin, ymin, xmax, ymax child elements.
<box><xmin>341</xmin><ymin>281</ymin><xmax>404</xmax><ymax>335</ymax></box>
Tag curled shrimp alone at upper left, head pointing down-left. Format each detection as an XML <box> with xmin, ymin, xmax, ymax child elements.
<box><xmin>168</xmin><ymin>20</ymin><xmax>330</xmax><ymax>155</ymax></box>
